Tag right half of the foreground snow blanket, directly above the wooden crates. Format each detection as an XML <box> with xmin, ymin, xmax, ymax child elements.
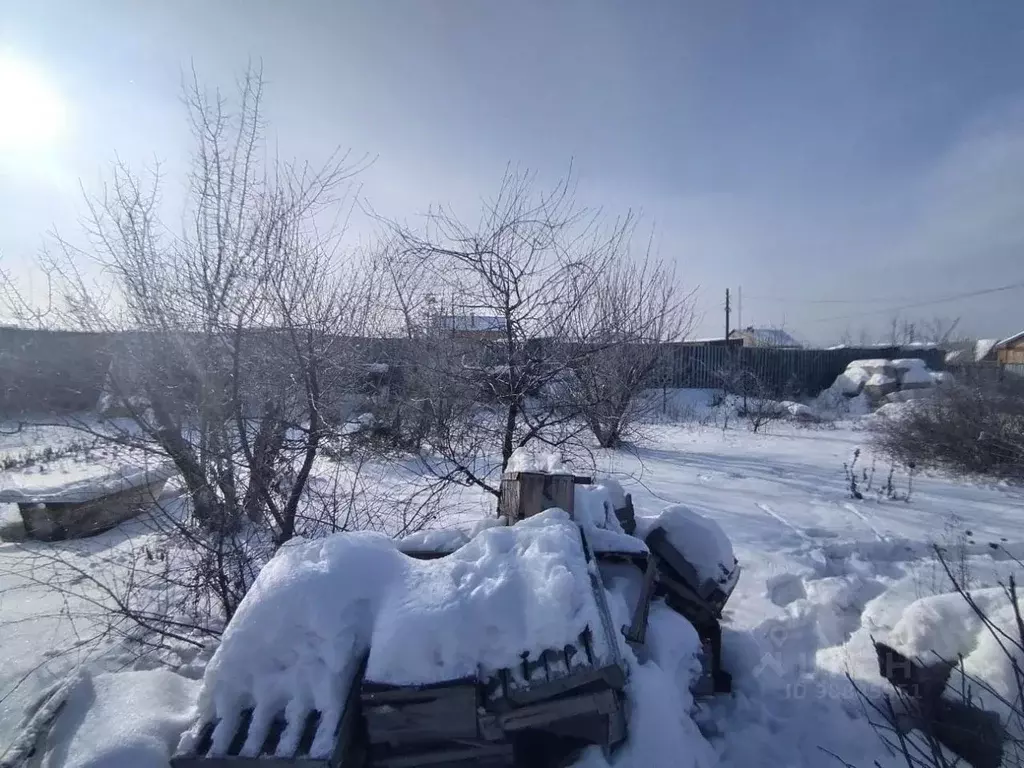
<box><xmin>367</xmin><ymin>510</ymin><xmax>600</xmax><ymax>685</ymax></box>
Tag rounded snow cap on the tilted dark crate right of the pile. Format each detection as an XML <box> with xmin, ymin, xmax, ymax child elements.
<box><xmin>637</xmin><ymin>504</ymin><xmax>739</xmax><ymax>592</ymax></box>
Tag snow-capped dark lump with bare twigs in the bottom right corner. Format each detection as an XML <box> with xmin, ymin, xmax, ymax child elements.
<box><xmin>854</xmin><ymin>548</ymin><xmax>1024</xmax><ymax>768</ymax></box>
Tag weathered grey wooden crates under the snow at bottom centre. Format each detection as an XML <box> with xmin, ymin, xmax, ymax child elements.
<box><xmin>360</xmin><ymin>528</ymin><xmax>626</xmax><ymax>768</ymax></box>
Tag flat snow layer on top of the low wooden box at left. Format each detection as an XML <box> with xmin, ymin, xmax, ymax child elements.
<box><xmin>0</xmin><ymin>463</ymin><xmax>174</xmax><ymax>504</ymax></box>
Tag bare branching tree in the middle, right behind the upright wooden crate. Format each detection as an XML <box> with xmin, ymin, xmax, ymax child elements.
<box><xmin>378</xmin><ymin>165</ymin><xmax>634</xmax><ymax>496</ymax></box>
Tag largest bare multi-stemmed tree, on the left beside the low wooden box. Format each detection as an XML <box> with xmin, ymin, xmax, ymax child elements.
<box><xmin>6</xmin><ymin>71</ymin><xmax>391</xmax><ymax>631</ymax></box>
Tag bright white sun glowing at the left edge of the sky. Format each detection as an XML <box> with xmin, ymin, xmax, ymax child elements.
<box><xmin>0</xmin><ymin>51</ymin><xmax>67</xmax><ymax>153</ymax></box>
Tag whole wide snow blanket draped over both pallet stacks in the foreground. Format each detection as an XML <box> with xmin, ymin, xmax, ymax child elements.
<box><xmin>182</xmin><ymin>510</ymin><xmax>600</xmax><ymax>757</ymax></box>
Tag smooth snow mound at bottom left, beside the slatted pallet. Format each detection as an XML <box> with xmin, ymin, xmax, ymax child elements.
<box><xmin>42</xmin><ymin>670</ymin><xmax>199</xmax><ymax>768</ymax></box>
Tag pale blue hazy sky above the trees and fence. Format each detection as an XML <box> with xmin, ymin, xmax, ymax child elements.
<box><xmin>0</xmin><ymin>0</ymin><xmax>1024</xmax><ymax>342</ymax></box>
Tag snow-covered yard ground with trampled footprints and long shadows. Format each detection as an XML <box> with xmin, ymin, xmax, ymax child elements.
<box><xmin>0</xmin><ymin>411</ymin><xmax>1024</xmax><ymax>768</ymax></box>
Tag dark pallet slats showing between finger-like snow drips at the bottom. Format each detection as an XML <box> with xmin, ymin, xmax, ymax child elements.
<box><xmin>171</xmin><ymin>658</ymin><xmax>366</xmax><ymax>768</ymax></box>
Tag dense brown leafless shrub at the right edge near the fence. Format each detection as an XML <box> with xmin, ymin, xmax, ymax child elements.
<box><xmin>873</xmin><ymin>381</ymin><xmax>1024</xmax><ymax>481</ymax></box>
